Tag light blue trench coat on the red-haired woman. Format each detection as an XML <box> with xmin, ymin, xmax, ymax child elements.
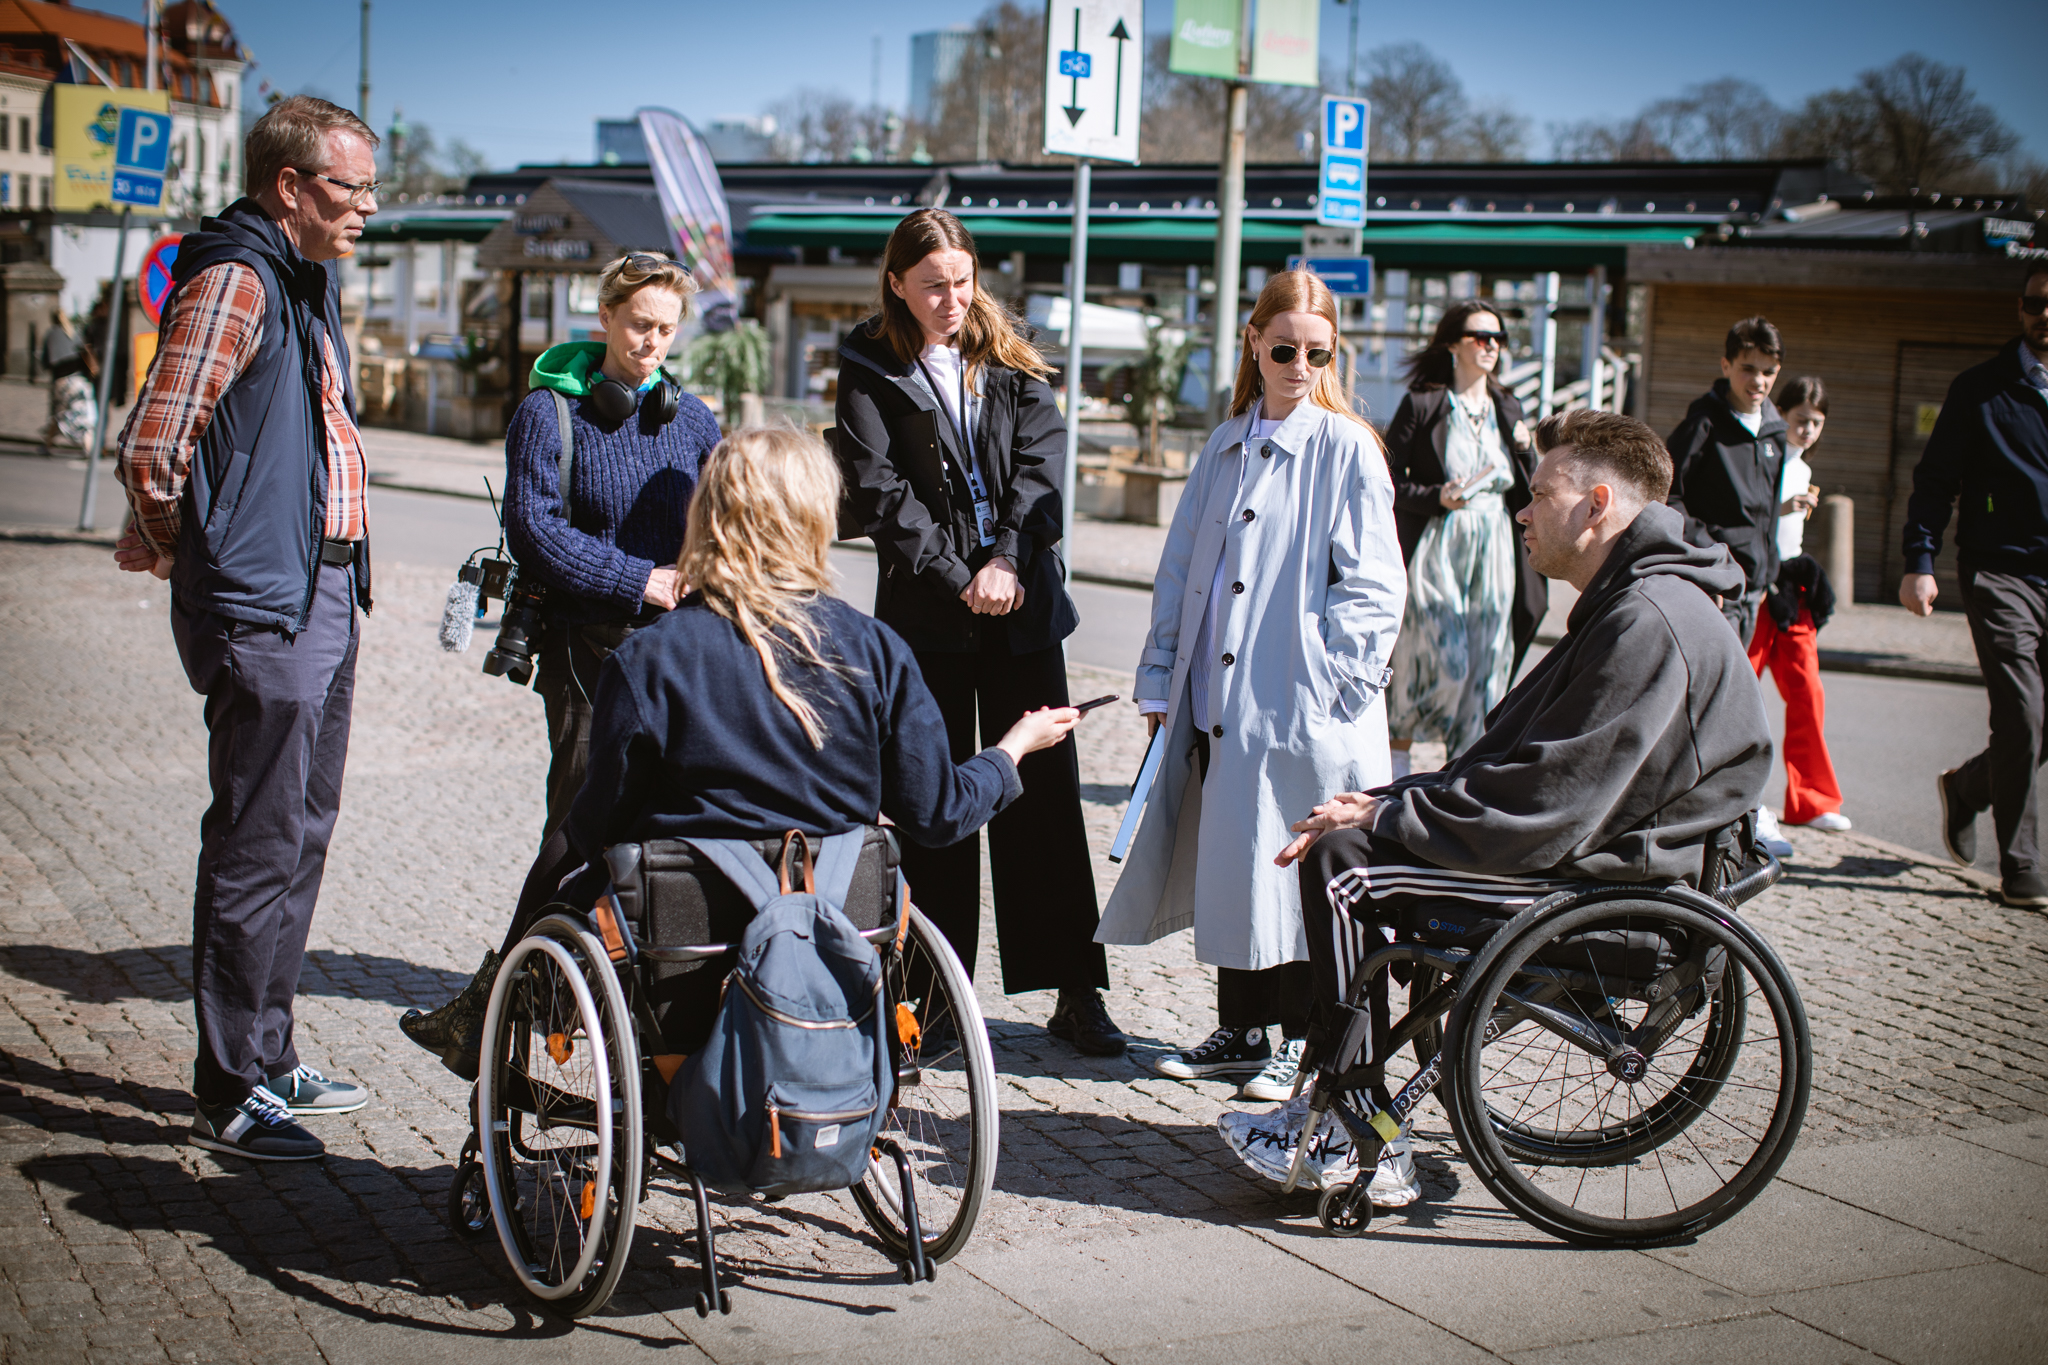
<box><xmin>1096</xmin><ymin>403</ymin><xmax>1407</xmax><ymax>970</ymax></box>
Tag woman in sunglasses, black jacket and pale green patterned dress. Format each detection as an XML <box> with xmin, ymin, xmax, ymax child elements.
<box><xmin>1386</xmin><ymin>299</ymin><xmax>1550</xmax><ymax>778</ymax></box>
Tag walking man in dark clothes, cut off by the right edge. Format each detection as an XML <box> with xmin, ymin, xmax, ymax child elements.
<box><xmin>1898</xmin><ymin>262</ymin><xmax>2048</xmax><ymax>907</ymax></box>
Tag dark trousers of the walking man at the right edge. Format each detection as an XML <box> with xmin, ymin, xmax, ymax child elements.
<box><xmin>1958</xmin><ymin>567</ymin><xmax>2048</xmax><ymax>876</ymax></box>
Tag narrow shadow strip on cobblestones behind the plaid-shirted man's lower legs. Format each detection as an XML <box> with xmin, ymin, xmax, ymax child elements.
<box><xmin>0</xmin><ymin>943</ymin><xmax>469</xmax><ymax>1007</ymax></box>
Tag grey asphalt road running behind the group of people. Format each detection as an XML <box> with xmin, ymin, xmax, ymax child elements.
<box><xmin>0</xmin><ymin>456</ymin><xmax>1997</xmax><ymax>870</ymax></box>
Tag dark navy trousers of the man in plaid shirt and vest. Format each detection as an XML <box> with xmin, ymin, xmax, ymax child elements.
<box><xmin>170</xmin><ymin>565</ymin><xmax>356</xmax><ymax>1107</ymax></box>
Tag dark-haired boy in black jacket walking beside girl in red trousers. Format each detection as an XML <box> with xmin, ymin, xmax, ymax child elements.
<box><xmin>1665</xmin><ymin>317</ymin><xmax>1786</xmax><ymax>647</ymax></box>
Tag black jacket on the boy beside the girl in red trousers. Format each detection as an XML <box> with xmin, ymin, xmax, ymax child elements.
<box><xmin>1665</xmin><ymin>379</ymin><xmax>1786</xmax><ymax>598</ymax></box>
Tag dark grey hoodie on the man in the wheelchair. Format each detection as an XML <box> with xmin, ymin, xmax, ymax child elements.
<box><xmin>1372</xmin><ymin>503</ymin><xmax>1772</xmax><ymax>882</ymax></box>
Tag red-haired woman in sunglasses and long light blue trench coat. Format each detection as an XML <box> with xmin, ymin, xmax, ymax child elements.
<box><xmin>1098</xmin><ymin>270</ymin><xmax>1407</xmax><ymax>1146</ymax></box>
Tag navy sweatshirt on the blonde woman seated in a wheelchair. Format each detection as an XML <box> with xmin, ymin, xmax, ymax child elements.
<box><xmin>567</xmin><ymin>593</ymin><xmax>1024</xmax><ymax>860</ymax></box>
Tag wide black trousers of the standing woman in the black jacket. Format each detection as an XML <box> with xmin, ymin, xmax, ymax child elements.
<box><xmin>903</xmin><ymin>622</ymin><xmax>1110</xmax><ymax>995</ymax></box>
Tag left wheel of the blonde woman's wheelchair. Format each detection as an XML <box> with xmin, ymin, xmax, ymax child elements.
<box><xmin>477</xmin><ymin>915</ymin><xmax>643</xmax><ymax>1318</ymax></box>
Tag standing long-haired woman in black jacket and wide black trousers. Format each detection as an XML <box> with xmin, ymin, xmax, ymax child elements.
<box><xmin>838</xmin><ymin>209</ymin><xmax>1124</xmax><ymax>1056</ymax></box>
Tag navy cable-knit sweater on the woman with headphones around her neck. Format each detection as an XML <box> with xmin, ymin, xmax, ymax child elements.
<box><xmin>506</xmin><ymin>378</ymin><xmax>719</xmax><ymax>624</ymax></box>
